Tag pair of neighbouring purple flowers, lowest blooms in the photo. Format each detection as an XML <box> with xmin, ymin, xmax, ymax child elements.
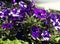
<box><xmin>31</xmin><ymin>26</ymin><xmax>51</xmax><ymax>41</ymax></box>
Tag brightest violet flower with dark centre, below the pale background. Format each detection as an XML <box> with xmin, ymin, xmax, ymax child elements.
<box><xmin>34</xmin><ymin>8</ymin><xmax>46</xmax><ymax>19</ymax></box>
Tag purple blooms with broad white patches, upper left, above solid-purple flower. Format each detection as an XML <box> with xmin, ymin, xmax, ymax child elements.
<box><xmin>9</xmin><ymin>8</ymin><xmax>25</xmax><ymax>21</ymax></box>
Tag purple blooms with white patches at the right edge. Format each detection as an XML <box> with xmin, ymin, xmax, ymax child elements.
<box><xmin>50</xmin><ymin>13</ymin><xmax>60</xmax><ymax>30</ymax></box>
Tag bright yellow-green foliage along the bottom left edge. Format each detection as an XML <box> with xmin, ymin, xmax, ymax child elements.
<box><xmin>0</xmin><ymin>39</ymin><xmax>29</xmax><ymax>44</ymax></box>
